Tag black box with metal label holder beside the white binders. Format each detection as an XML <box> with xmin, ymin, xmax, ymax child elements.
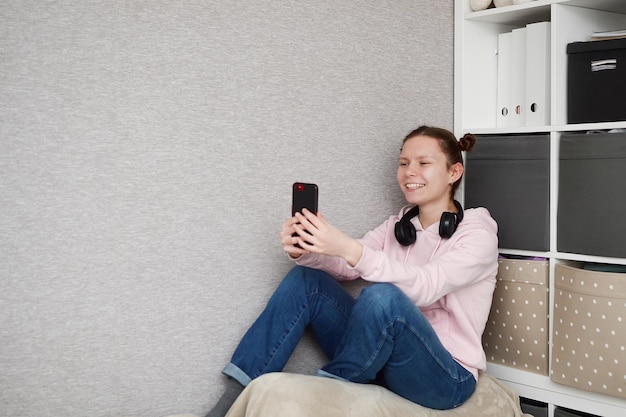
<box><xmin>567</xmin><ymin>39</ymin><xmax>626</xmax><ymax>123</ymax></box>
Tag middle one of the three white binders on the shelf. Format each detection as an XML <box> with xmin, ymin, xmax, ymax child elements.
<box><xmin>510</xmin><ymin>27</ymin><xmax>526</xmax><ymax>127</ymax></box>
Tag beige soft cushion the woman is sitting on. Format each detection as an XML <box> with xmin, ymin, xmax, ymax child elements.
<box><xmin>222</xmin><ymin>373</ymin><xmax>532</xmax><ymax>417</ymax></box>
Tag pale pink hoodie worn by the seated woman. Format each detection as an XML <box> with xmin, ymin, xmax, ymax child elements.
<box><xmin>296</xmin><ymin>207</ymin><xmax>498</xmax><ymax>378</ymax></box>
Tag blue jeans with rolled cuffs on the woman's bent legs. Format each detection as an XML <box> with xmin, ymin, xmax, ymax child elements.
<box><xmin>223</xmin><ymin>266</ymin><xmax>476</xmax><ymax>409</ymax></box>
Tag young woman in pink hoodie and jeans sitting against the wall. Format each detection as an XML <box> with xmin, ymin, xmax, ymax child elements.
<box><xmin>207</xmin><ymin>126</ymin><xmax>498</xmax><ymax>417</ymax></box>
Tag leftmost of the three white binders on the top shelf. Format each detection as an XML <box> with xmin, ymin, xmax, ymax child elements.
<box><xmin>496</xmin><ymin>32</ymin><xmax>513</xmax><ymax>127</ymax></box>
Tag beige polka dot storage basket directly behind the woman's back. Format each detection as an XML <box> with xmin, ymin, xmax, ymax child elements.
<box><xmin>483</xmin><ymin>259</ymin><xmax>549</xmax><ymax>375</ymax></box>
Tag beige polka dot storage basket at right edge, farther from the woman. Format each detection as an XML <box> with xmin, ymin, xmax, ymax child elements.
<box><xmin>550</xmin><ymin>264</ymin><xmax>626</xmax><ymax>398</ymax></box>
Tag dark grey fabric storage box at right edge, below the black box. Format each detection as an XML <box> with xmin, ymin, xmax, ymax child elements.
<box><xmin>557</xmin><ymin>132</ymin><xmax>626</xmax><ymax>258</ymax></box>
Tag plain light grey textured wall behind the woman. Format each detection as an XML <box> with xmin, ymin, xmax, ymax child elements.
<box><xmin>0</xmin><ymin>0</ymin><xmax>453</xmax><ymax>417</ymax></box>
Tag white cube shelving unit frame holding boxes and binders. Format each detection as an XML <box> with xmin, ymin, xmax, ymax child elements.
<box><xmin>454</xmin><ymin>0</ymin><xmax>626</xmax><ymax>417</ymax></box>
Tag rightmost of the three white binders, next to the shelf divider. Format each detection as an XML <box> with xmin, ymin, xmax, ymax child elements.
<box><xmin>524</xmin><ymin>22</ymin><xmax>550</xmax><ymax>126</ymax></box>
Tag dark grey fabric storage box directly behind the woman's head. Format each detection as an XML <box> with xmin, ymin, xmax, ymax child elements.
<box><xmin>464</xmin><ymin>134</ymin><xmax>550</xmax><ymax>251</ymax></box>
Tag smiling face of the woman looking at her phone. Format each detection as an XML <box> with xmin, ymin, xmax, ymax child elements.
<box><xmin>397</xmin><ymin>135</ymin><xmax>463</xmax><ymax>212</ymax></box>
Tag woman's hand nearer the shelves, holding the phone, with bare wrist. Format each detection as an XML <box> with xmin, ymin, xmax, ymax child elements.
<box><xmin>294</xmin><ymin>209</ymin><xmax>363</xmax><ymax>266</ymax></box>
